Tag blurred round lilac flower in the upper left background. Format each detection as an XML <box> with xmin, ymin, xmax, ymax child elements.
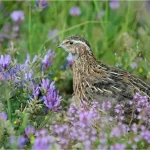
<box><xmin>10</xmin><ymin>10</ymin><xmax>24</xmax><ymax>22</ymax></box>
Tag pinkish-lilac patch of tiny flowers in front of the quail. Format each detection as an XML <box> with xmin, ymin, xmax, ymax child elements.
<box><xmin>42</xmin><ymin>93</ymin><xmax>150</xmax><ymax>150</ymax></box>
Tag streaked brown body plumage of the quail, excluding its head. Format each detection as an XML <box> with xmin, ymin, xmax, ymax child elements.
<box><xmin>73</xmin><ymin>53</ymin><xmax>150</xmax><ymax>103</ymax></box>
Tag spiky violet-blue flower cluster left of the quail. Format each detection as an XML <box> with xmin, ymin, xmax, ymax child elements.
<box><xmin>0</xmin><ymin>50</ymin><xmax>61</xmax><ymax>111</ymax></box>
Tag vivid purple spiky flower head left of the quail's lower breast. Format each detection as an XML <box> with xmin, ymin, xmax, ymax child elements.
<box><xmin>43</xmin><ymin>88</ymin><xmax>62</xmax><ymax>111</ymax></box>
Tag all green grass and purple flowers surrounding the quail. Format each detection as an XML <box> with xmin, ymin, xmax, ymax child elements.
<box><xmin>0</xmin><ymin>0</ymin><xmax>150</xmax><ymax>150</ymax></box>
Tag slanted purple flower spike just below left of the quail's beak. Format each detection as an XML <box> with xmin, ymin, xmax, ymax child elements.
<box><xmin>42</xmin><ymin>50</ymin><xmax>56</xmax><ymax>70</ymax></box>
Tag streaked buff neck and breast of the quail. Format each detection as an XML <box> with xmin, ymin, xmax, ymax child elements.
<box><xmin>73</xmin><ymin>53</ymin><xmax>110</xmax><ymax>105</ymax></box>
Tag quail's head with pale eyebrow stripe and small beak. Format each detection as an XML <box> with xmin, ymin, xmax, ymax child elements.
<box><xmin>58</xmin><ymin>36</ymin><xmax>92</xmax><ymax>59</ymax></box>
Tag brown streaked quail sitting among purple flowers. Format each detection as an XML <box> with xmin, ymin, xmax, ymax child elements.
<box><xmin>59</xmin><ymin>36</ymin><xmax>150</xmax><ymax>109</ymax></box>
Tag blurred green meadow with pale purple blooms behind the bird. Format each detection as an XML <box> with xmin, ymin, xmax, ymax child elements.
<box><xmin>0</xmin><ymin>0</ymin><xmax>150</xmax><ymax>85</ymax></box>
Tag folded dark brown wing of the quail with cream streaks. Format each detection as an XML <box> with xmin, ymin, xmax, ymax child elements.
<box><xmin>84</xmin><ymin>63</ymin><xmax>150</xmax><ymax>101</ymax></box>
